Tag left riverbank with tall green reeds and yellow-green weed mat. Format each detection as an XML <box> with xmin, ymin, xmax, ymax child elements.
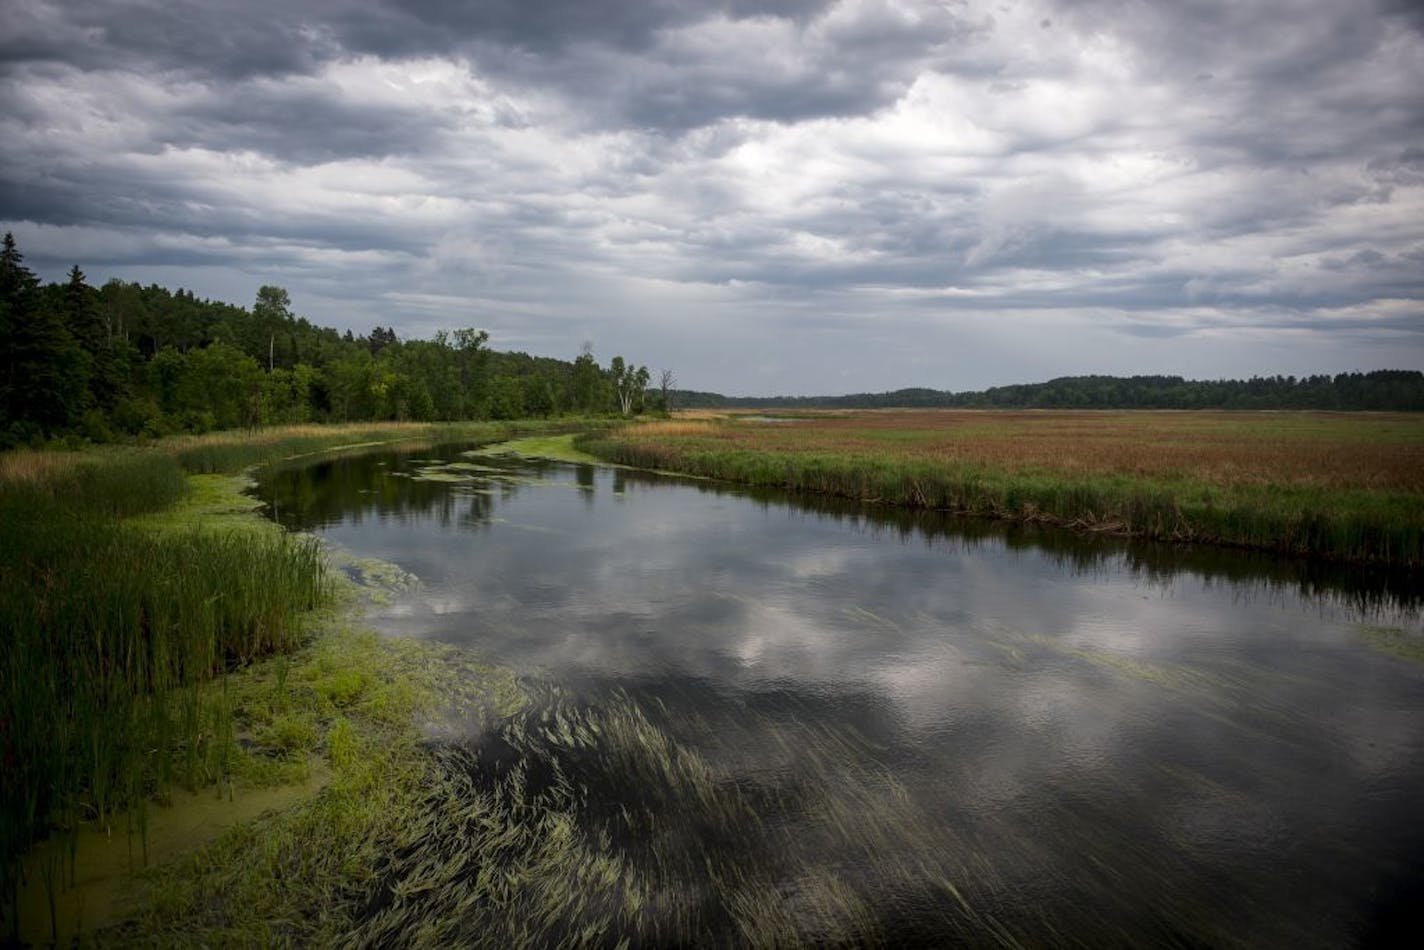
<box><xmin>0</xmin><ymin>424</ymin><xmax>528</xmax><ymax>943</ymax></box>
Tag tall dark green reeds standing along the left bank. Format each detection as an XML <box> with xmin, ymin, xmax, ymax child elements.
<box><xmin>0</xmin><ymin>449</ymin><xmax>329</xmax><ymax>940</ymax></box>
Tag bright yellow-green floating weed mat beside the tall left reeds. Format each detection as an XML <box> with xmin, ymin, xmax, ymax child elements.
<box><xmin>6</xmin><ymin>581</ymin><xmax>524</xmax><ymax>946</ymax></box>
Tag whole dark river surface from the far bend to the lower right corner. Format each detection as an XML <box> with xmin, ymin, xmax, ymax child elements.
<box><xmin>261</xmin><ymin>447</ymin><xmax>1424</xmax><ymax>946</ymax></box>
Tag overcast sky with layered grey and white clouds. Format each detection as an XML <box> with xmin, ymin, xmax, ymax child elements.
<box><xmin>0</xmin><ymin>0</ymin><xmax>1424</xmax><ymax>395</ymax></box>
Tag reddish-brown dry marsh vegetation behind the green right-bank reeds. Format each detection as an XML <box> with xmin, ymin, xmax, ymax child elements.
<box><xmin>643</xmin><ymin>410</ymin><xmax>1424</xmax><ymax>493</ymax></box>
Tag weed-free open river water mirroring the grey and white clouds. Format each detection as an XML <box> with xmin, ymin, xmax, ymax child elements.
<box><xmin>259</xmin><ymin>447</ymin><xmax>1424</xmax><ymax>939</ymax></box>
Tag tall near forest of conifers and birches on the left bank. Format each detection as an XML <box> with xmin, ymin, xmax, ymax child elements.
<box><xmin>0</xmin><ymin>234</ymin><xmax>660</xmax><ymax>447</ymax></box>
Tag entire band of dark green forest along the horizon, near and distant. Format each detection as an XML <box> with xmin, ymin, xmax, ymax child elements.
<box><xmin>0</xmin><ymin>234</ymin><xmax>1424</xmax><ymax>449</ymax></box>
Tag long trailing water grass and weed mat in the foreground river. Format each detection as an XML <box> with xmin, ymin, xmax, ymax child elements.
<box><xmin>128</xmin><ymin>684</ymin><xmax>1258</xmax><ymax>947</ymax></box>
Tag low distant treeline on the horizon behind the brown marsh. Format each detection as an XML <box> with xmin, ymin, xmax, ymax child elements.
<box><xmin>672</xmin><ymin>369</ymin><xmax>1424</xmax><ymax>412</ymax></box>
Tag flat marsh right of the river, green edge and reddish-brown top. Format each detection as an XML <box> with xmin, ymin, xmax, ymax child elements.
<box><xmin>575</xmin><ymin>414</ymin><xmax>1424</xmax><ymax>567</ymax></box>
